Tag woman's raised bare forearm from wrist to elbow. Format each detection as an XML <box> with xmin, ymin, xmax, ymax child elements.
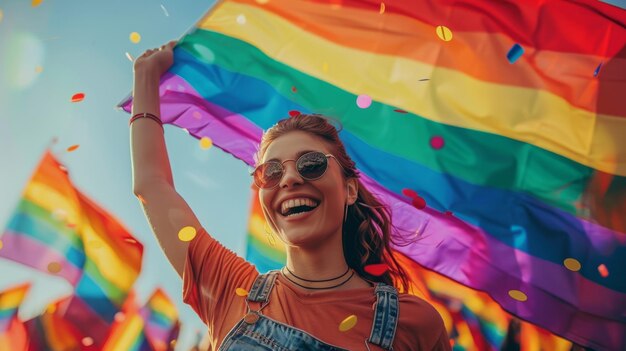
<box><xmin>130</xmin><ymin>70</ymin><xmax>174</xmax><ymax>192</ymax></box>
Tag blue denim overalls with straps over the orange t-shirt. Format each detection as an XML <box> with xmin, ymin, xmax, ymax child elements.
<box><xmin>219</xmin><ymin>270</ymin><xmax>399</xmax><ymax>351</ymax></box>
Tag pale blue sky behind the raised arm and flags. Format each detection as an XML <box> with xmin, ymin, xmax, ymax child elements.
<box><xmin>0</xmin><ymin>0</ymin><xmax>251</xmax><ymax>350</ymax></box>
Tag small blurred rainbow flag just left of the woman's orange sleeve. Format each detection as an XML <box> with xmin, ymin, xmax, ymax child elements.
<box><xmin>139</xmin><ymin>288</ymin><xmax>180</xmax><ymax>351</ymax></box>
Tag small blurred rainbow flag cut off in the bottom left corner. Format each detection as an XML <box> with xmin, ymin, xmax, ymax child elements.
<box><xmin>0</xmin><ymin>283</ymin><xmax>31</xmax><ymax>350</ymax></box>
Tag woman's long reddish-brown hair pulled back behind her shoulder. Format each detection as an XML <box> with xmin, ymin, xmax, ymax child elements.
<box><xmin>256</xmin><ymin>114</ymin><xmax>410</xmax><ymax>292</ymax></box>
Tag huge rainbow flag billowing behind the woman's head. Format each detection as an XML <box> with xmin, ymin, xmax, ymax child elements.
<box><xmin>120</xmin><ymin>0</ymin><xmax>626</xmax><ymax>350</ymax></box>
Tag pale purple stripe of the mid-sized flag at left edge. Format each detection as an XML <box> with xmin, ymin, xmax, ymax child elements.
<box><xmin>0</xmin><ymin>230</ymin><xmax>82</xmax><ymax>285</ymax></box>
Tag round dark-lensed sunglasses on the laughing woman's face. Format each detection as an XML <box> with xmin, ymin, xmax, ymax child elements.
<box><xmin>250</xmin><ymin>151</ymin><xmax>336</xmax><ymax>189</ymax></box>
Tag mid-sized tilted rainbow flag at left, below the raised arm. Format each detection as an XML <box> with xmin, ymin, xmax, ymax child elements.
<box><xmin>0</xmin><ymin>151</ymin><xmax>143</xmax><ymax>345</ymax></box>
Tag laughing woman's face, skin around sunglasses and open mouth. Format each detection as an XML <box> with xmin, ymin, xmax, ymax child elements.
<box><xmin>259</xmin><ymin>131</ymin><xmax>356</xmax><ymax>247</ymax></box>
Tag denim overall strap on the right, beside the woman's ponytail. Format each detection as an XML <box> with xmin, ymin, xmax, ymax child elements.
<box><xmin>368</xmin><ymin>282</ymin><xmax>400</xmax><ymax>350</ymax></box>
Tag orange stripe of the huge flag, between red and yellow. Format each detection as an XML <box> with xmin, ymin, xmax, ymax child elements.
<box><xmin>227</xmin><ymin>0</ymin><xmax>626</xmax><ymax>115</ymax></box>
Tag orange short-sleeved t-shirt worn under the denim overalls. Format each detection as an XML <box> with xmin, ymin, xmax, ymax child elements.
<box><xmin>183</xmin><ymin>229</ymin><xmax>450</xmax><ymax>351</ymax></box>
